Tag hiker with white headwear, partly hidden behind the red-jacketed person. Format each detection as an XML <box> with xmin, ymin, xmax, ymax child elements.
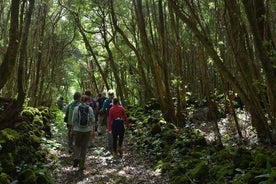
<box><xmin>101</xmin><ymin>89</ymin><xmax>114</xmax><ymax>153</ymax></box>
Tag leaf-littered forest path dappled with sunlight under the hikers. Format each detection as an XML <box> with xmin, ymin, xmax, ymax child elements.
<box><xmin>53</xmin><ymin>131</ymin><xmax>169</xmax><ymax>184</ymax></box>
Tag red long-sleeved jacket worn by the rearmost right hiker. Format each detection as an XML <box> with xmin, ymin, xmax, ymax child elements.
<box><xmin>108</xmin><ymin>104</ymin><xmax>129</xmax><ymax>131</ymax></box>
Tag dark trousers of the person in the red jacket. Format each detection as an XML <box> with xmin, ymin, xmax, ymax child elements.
<box><xmin>112</xmin><ymin>120</ymin><xmax>125</xmax><ymax>152</ymax></box>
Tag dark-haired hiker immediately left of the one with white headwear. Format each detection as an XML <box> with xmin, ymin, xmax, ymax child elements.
<box><xmin>97</xmin><ymin>92</ymin><xmax>107</xmax><ymax>135</ymax></box>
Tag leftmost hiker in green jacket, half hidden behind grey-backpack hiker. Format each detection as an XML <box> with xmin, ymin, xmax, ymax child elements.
<box><xmin>64</xmin><ymin>92</ymin><xmax>81</xmax><ymax>153</ymax></box>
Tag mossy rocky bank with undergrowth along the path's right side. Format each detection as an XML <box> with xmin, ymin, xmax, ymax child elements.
<box><xmin>130</xmin><ymin>100</ymin><xmax>276</xmax><ymax>184</ymax></box>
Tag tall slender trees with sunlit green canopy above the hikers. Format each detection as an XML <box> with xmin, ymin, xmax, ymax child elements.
<box><xmin>0</xmin><ymin>0</ymin><xmax>276</xmax><ymax>143</ymax></box>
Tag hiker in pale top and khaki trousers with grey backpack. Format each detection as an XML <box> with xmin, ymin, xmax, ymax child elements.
<box><xmin>71</xmin><ymin>95</ymin><xmax>95</xmax><ymax>170</ymax></box>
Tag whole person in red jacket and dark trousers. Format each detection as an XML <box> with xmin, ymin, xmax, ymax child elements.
<box><xmin>108</xmin><ymin>98</ymin><xmax>130</xmax><ymax>156</ymax></box>
